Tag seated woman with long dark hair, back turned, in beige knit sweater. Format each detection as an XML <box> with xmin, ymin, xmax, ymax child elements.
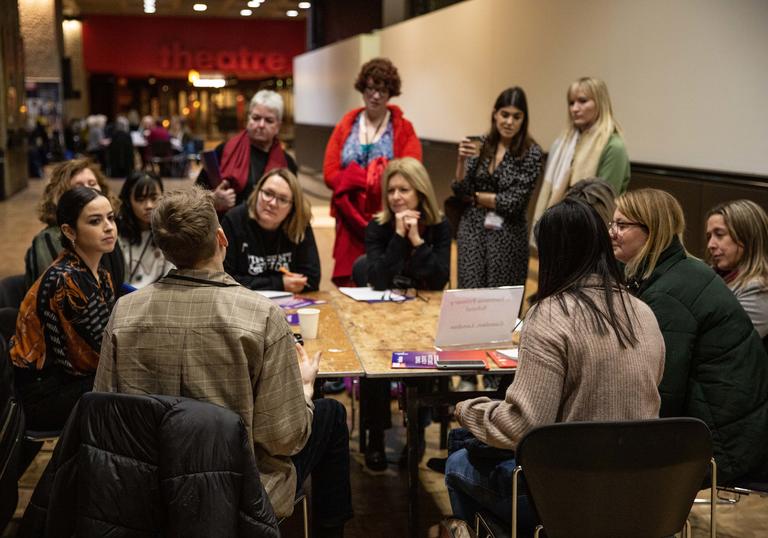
<box><xmin>445</xmin><ymin>199</ymin><xmax>664</xmax><ymax>523</ymax></box>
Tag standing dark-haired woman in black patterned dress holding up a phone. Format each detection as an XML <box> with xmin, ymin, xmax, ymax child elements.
<box><xmin>451</xmin><ymin>86</ymin><xmax>543</xmax><ymax>288</ymax></box>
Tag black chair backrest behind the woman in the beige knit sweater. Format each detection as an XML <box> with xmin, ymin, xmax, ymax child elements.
<box><xmin>516</xmin><ymin>418</ymin><xmax>712</xmax><ymax>538</ymax></box>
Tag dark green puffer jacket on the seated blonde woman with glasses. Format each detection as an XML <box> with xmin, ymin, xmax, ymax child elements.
<box><xmin>636</xmin><ymin>239</ymin><xmax>768</xmax><ymax>484</ymax></box>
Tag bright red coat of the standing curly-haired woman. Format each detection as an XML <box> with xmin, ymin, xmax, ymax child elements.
<box><xmin>323</xmin><ymin>105</ymin><xmax>421</xmax><ymax>284</ymax></box>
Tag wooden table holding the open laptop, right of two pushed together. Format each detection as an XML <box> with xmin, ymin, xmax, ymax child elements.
<box><xmin>327</xmin><ymin>290</ymin><xmax>513</xmax><ymax>538</ymax></box>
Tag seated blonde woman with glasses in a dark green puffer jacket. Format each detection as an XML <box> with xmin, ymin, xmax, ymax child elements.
<box><xmin>610</xmin><ymin>189</ymin><xmax>768</xmax><ymax>483</ymax></box>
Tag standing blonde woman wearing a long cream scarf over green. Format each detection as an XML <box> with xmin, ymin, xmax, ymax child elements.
<box><xmin>534</xmin><ymin>77</ymin><xmax>630</xmax><ymax>222</ymax></box>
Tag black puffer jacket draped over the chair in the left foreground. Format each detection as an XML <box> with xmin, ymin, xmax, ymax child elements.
<box><xmin>19</xmin><ymin>393</ymin><xmax>280</xmax><ymax>538</ymax></box>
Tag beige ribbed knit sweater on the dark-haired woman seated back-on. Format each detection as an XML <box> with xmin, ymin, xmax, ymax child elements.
<box><xmin>456</xmin><ymin>288</ymin><xmax>664</xmax><ymax>449</ymax></box>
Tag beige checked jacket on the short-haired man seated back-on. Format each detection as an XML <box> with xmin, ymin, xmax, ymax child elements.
<box><xmin>93</xmin><ymin>270</ymin><xmax>314</xmax><ymax>517</ymax></box>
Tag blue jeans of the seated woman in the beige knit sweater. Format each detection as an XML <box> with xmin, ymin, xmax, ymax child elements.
<box><xmin>445</xmin><ymin>448</ymin><xmax>536</xmax><ymax>536</ymax></box>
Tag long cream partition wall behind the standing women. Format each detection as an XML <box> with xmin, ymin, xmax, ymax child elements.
<box><xmin>294</xmin><ymin>0</ymin><xmax>768</xmax><ymax>175</ymax></box>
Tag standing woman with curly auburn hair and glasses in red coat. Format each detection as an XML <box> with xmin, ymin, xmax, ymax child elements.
<box><xmin>323</xmin><ymin>58</ymin><xmax>421</xmax><ymax>286</ymax></box>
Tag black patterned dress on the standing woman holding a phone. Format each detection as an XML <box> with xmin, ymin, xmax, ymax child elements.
<box><xmin>451</xmin><ymin>140</ymin><xmax>543</xmax><ymax>288</ymax></box>
